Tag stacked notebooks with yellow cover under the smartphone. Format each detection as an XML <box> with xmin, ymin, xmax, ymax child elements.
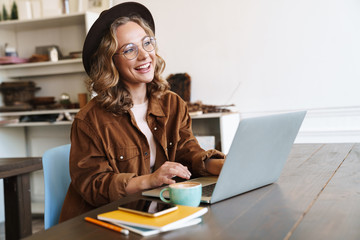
<box><xmin>97</xmin><ymin>205</ymin><xmax>208</xmax><ymax>236</ymax></box>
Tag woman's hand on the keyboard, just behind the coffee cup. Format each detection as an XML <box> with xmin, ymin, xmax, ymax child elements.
<box><xmin>150</xmin><ymin>161</ymin><xmax>191</xmax><ymax>188</ymax></box>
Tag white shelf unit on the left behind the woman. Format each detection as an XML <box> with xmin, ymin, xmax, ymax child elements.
<box><xmin>0</xmin><ymin>12</ymin><xmax>99</xmax><ymax>217</ymax></box>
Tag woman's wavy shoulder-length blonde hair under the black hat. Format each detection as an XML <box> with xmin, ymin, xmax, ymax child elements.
<box><xmin>87</xmin><ymin>16</ymin><xmax>169</xmax><ymax>115</ymax></box>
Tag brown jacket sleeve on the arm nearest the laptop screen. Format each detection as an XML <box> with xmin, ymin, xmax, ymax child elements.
<box><xmin>175</xmin><ymin>96</ymin><xmax>225</xmax><ymax>177</ymax></box>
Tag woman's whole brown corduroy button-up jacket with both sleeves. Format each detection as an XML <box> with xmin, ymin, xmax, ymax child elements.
<box><xmin>60</xmin><ymin>91</ymin><xmax>225</xmax><ymax>222</ymax></box>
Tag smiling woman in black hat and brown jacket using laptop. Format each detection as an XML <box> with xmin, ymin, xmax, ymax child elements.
<box><xmin>60</xmin><ymin>3</ymin><xmax>225</xmax><ymax>221</ymax></box>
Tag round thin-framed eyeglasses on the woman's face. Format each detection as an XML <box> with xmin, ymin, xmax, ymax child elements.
<box><xmin>114</xmin><ymin>36</ymin><xmax>156</xmax><ymax>60</ymax></box>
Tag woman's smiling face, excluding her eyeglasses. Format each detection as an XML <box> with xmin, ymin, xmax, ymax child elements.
<box><xmin>113</xmin><ymin>22</ymin><xmax>156</xmax><ymax>90</ymax></box>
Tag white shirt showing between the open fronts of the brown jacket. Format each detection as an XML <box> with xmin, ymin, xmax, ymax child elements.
<box><xmin>131</xmin><ymin>101</ymin><xmax>156</xmax><ymax>168</ymax></box>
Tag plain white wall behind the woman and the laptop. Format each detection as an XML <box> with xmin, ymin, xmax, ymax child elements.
<box><xmin>114</xmin><ymin>0</ymin><xmax>360</xmax><ymax>142</ymax></box>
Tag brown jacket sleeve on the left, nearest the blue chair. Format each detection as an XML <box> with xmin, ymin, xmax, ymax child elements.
<box><xmin>70</xmin><ymin>119</ymin><xmax>136</xmax><ymax>207</ymax></box>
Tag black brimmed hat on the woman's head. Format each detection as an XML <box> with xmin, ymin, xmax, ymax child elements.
<box><xmin>82</xmin><ymin>2</ymin><xmax>155</xmax><ymax>74</ymax></box>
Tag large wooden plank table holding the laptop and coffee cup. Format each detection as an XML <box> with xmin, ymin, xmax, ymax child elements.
<box><xmin>23</xmin><ymin>144</ymin><xmax>360</xmax><ymax>240</ymax></box>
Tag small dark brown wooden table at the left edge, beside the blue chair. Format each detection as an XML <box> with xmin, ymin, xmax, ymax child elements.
<box><xmin>0</xmin><ymin>158</ymin><xmax>42</xmax><ymax>240</ymax></box>
